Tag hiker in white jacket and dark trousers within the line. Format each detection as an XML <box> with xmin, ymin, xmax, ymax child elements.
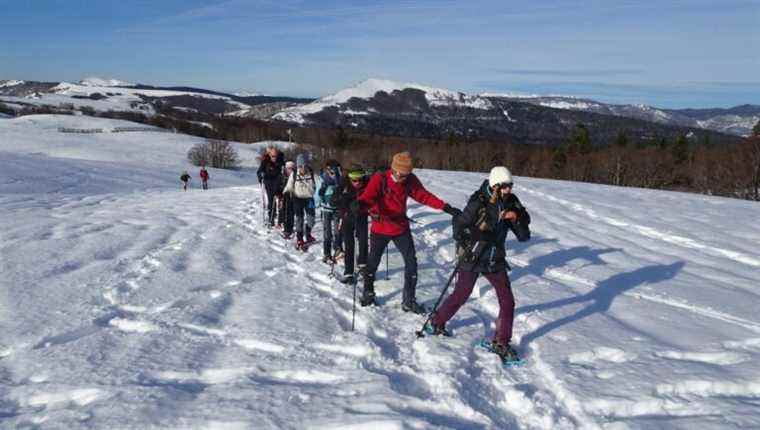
<box><xmin>285</xmin><ymin>154</ymin><xmax>316</xmax><ymax>252</ymax></box>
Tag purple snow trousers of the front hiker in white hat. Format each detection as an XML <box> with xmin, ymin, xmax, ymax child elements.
<box><xmin>433</xmin><ymin>270</ymin><xmax>515</xmax><ymax>345</ymax></box>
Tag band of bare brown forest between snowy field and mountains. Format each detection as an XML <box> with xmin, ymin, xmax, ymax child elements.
<box><xmin>4</xmin><ymin>101</ymin><xmax>760</xmax><ymax>201</ymax></box>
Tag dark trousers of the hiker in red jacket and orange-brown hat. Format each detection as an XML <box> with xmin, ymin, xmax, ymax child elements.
<box><xmin>364</xmin><ymin>230</ymin><xmax>417</xmax><ymax>306</ymax></box>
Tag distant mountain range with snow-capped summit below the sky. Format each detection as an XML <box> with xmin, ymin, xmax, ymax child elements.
<box><xmin>0</xmin><ymin>78</ymin><xmax>760</xmax><ymax>145</ymax></box>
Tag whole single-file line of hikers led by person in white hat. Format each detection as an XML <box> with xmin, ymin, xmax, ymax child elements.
<box><xmin>258</xmin><ymin>147</ymin><xmax>530</xmax><ymax>360</ymax></box>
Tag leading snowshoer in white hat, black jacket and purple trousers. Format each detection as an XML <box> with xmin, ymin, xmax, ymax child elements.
<box><xmin>425</xmin><ymin>166</ymin><xmax>530</xmax><ymax>362</ymax></box>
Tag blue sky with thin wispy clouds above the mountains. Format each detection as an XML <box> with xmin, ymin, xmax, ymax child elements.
<box><xmin>0</xmin><ymin>0</ymin><xmax>760</xmax><ymax>108</ymax></box>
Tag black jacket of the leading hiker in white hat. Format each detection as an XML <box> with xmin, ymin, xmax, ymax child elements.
<box><xmin>453</xmin><ymin>181</ymin><xmax>530</xmax><ymax>273</ymax></box>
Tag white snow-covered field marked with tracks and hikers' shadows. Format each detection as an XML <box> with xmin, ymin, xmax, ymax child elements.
<box><xmin>0</xmin><ymin>116</ymin><xmax>760</xmax><ymax>429</ymax></box>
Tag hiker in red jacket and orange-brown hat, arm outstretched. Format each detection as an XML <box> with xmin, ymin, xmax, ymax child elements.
<box><xmin>352</xmin><ymin>152</ymin><xmax>461</xmax><ymax>314</ymax></box>
